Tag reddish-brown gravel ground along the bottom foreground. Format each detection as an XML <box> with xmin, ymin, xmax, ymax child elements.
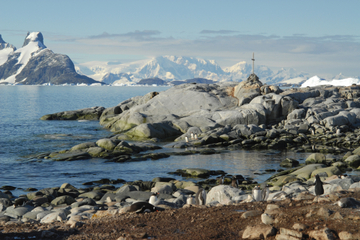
<box><xmin>0</xmin><ymin>192</ymin><xmax>360</xmax><ymax>240</ymax></box>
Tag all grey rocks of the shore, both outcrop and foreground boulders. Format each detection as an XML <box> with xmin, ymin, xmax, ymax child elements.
<box><xmin>0</xmin><ymin>75</ymin><xmax>360</xmax><ymax>239</ymax></box>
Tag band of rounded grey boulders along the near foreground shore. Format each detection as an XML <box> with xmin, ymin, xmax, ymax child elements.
<box><xmin>0</xmin><ymin>156</ymin><xmax>360</xmax><ymax>239</ymax></box>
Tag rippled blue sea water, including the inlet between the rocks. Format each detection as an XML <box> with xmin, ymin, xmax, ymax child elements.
<box><xmin>0</xmin><ymin>85</ymin><xmax>310</xmax><ymax>194</ymax></box>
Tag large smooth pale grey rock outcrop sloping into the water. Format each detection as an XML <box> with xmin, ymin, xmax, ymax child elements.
<box><xmin>100</xmin><ymin>84</ymin><xmax>237</xmax><ymax>139</ymax></box>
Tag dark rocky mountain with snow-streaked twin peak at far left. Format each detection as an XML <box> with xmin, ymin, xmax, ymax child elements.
<box><xmin>0</xmin><ymin>32</ymin><xmax>97</xmax><ymax>84</ymax></box>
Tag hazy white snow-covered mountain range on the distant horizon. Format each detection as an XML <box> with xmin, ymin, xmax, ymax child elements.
<box><xmin>76</xmin><ymin>56</ymin><xmax>307</xmax><ymax>85</ymax></box>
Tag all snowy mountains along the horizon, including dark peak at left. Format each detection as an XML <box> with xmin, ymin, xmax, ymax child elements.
<box><xmin>0</xmin><ymin>32</ymin><xmax>354</xmax><ymax>85</ymax></box>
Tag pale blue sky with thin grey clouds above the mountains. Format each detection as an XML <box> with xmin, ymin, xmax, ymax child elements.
<box><xmin>0</xmin><ymin>0</ymin><xmax>360</xmax><ymax>77</ymax></box>
